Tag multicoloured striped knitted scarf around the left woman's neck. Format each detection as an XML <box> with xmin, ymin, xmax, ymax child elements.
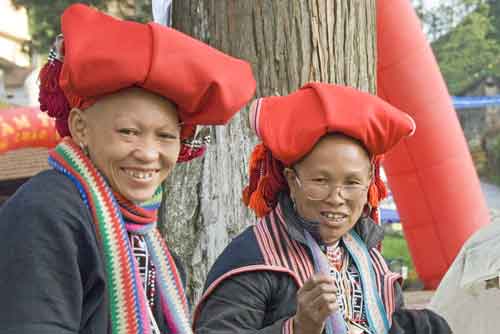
<box><xmin>49</xmin><ymin>138</ymin><xmax>192</xmax><ymax>334</ymax></box>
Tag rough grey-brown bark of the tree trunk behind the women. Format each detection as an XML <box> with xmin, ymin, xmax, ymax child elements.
<box><xmin>162</xmin><ymin>0</ymin><xmax>376</xmax><ymax>302</ymax></box>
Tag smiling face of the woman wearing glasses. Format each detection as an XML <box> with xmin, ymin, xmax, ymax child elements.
<box><xmin>285</xmin><ymin>134</ymin><xmax>371</xmax><ymax>245</ymax></box>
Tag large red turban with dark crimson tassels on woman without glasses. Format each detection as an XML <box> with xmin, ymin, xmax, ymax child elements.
<box><xmin>40</xmin><ymin>4</ymin><xmax>255</xmax><ymax>162</ymax></box>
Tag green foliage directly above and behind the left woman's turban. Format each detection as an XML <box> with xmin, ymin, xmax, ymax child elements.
<box><xmin>11</xmin><ymin>0</ymin><xmax>151</xmax><ymax>54</ymax></box>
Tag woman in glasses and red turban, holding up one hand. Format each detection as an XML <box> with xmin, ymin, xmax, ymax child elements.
<box><xmin>195</xmin><ymin>83</ymin><xmax>447</xmax><ymax>334</ymax></box>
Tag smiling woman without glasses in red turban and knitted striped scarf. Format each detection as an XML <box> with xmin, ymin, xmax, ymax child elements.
<box><xmin>0</xmin><ymin>5</ymin><xmax>255</xmax><ymax>334</ymax></box>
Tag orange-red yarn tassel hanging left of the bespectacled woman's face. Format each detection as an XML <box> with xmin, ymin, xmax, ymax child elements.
<box><xmin>242</xmin><ymin>143</ymin><xmax>288</xmax><ymax>217</ymax></box>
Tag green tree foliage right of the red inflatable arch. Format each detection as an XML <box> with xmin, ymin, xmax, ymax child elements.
<box><xmin>432</xmin><ymin>0</ymin><xmax>500</xmax><ymax>95</ymax></box>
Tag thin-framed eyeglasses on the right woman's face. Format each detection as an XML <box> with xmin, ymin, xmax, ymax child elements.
<box><xmin>292</xmin><ymin>169</ymin><xmax>368</xmax><ymax>201</ymax></box>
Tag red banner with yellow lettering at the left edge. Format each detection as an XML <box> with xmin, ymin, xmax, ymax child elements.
<box><xmin>0</xmin><ymin>108</ymin><xmax>60</xmax><ymax>154</ymax></box>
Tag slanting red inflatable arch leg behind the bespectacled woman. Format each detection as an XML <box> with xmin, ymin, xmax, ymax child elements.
<box><xmin>377</xmin><ymin>0</ymin><xmax>489</xmax><ymax>288</ymax></box>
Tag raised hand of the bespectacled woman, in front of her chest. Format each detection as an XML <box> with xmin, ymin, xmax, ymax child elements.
<box><xmin>293</xmin><ymin>274</ymin><xmax>338</xmax><ymax>334</ymax></box>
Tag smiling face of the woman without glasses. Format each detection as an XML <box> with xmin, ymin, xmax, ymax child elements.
<box><xmin>69</xmin><ymin>88</ymin><xmax>180</xmax><ymax>202</ymax></box>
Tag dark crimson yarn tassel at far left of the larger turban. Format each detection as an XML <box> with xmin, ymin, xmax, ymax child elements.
<box><xmin>38</xmin><ymin>59</ymin><xmax>70</xmax><ymax>137</ymax></box>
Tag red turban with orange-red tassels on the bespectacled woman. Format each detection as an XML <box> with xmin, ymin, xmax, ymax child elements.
<box><xmin>243</xmin><ymin>83</ymin><xmax>415</xmax><ymax>216</ymax></box>
